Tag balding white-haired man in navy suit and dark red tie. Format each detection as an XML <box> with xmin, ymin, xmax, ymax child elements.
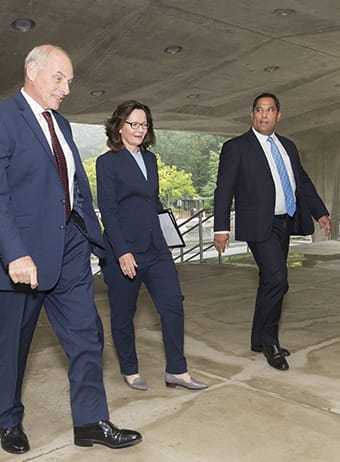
<box><xmin>0</xmin><ymin>45</ymin><xmax>141</xmax><ymax>454</ymax></box>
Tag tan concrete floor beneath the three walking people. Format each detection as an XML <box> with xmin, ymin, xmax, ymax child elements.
<box><xmin>0</xmin><ymin>242</ymin><xmax>340</xmax><ymax>462</ymax></box>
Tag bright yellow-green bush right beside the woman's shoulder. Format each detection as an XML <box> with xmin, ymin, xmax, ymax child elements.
<box><xmin>157</xmin><ymin>155</ymin><xmax>197</xmax><ymax>207</ymax></box>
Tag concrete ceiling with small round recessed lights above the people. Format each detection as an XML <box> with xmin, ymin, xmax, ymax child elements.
<box><xmin>0</xmin><ymin>0</ymin><xmax>340</xmax><ymax>136</ymax></box>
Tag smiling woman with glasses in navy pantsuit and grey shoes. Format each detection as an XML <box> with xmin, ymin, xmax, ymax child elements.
<box><xmin>97</xmin><ymin>101</ymin><xmax>206</xmax><ymax>390</ymax></box>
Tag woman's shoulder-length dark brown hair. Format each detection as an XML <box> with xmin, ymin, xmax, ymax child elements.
<box><xmin>105</xmin><ymin>100</ymin><xmax>156</xmax><ymax>152</ymax></box>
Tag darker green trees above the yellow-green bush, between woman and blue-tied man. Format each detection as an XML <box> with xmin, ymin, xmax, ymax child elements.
<box><xmin>156</xmin><ymin>130</ymin><xmax>225</xmax><ymax>196</ymax></box>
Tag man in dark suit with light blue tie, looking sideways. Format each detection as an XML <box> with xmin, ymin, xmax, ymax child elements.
<box><xmin>214</xmin><ymin>93</ymin><xmax>331</xmax><ymax>370</ymax></box>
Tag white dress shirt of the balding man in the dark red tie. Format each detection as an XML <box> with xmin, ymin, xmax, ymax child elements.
<box><xmin>21</xmin><ymin>88</ymin><xmax>76</xmax><ymax>210</ymax></box>
